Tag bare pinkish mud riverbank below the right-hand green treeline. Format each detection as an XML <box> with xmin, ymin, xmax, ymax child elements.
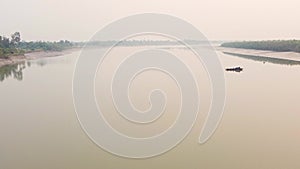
<box><xmin>216</xmin><ymin>47</ymin><xmax>300</xmax><ymax>62</ymax></box>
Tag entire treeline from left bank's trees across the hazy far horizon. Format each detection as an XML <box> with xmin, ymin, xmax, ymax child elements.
<box><xmin>0</xmin><ymin>32</ymin><xmax>221</xmax><ymax>58</ymax></box>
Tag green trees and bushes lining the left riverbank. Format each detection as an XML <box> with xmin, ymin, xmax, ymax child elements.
<box><xmin>0</xmin><ymin>32</ymin><xmax>75</xmax><ymax>58</ymax></box>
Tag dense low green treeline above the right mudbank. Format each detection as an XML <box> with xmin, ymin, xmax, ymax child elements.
<box><xmin>221</xmin><ymin>40</ymin><xmax>300</xmax><ymax>52</ymax></box>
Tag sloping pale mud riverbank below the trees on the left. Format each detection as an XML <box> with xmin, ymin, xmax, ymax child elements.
<box><xmin>0</xmin><ymin>48</ymin><xmax>80</xmax><ymax>67</ymax></box>
